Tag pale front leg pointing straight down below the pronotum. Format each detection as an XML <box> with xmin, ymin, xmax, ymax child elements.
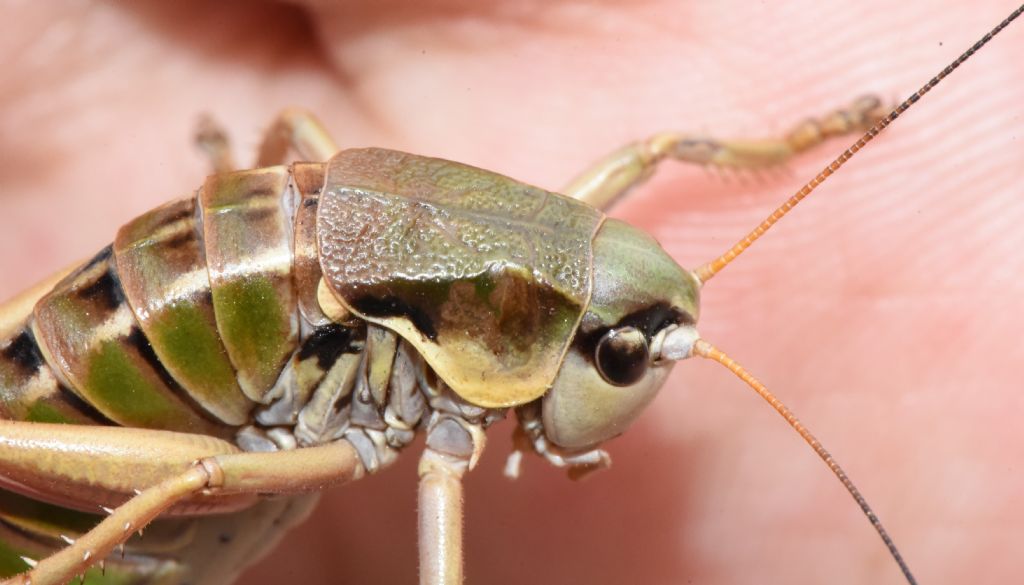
<box><xmin>419</xmin><ymin>413</ymin><xmax>483</xmax><ymax>585</ymax></box>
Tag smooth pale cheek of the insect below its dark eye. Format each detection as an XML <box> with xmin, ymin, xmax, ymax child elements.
<box><xmin>543</xmin><ymin>350</ymin><xmax>672</xmax><ymax>449</ymax></box>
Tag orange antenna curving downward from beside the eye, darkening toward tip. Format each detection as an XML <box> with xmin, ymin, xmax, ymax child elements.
<box><xmin>693</xmin><ymin>339</ymin><xmax>918</xmax><ymax>585</ymax></box>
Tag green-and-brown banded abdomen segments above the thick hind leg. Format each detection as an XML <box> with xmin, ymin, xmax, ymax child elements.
<box><xmin>0</xmin><ymin>164</ymin><xmax>325</xmax><ymax>436</ymax></box>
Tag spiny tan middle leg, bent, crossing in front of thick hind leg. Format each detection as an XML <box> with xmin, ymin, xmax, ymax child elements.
<box><xmin>4</xmin><ymin>440</ymin><xmax>364</xmax><ymax>585</ymax></box>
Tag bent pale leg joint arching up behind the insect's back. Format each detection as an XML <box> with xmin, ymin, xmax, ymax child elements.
<box><xmin>256</xmin><ymin>108</ymin><xmax>339</xmax><ymax>167</ymax></box>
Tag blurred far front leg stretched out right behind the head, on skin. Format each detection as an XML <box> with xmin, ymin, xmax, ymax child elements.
<box><xmin>562</xmin><ymin>95</ymin><xmax>888</xmax><ymax>209</ymax></box>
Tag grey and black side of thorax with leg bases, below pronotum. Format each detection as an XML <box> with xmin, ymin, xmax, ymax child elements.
<box><xmin>237</xmin><ymin>320</ymin><xmax>506</xmax><ymax>472</ymax></box>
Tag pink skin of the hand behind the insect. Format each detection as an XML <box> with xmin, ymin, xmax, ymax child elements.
<box><xmin>0</xmin><ymin>0</ymin><xmax>1024</xmax><ymax>584</ymax></box>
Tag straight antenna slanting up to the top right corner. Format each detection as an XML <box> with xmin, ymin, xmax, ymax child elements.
<box><xmin>693</xmin><ymin>5</ymin><xmax>1024</xmax><ymax>283</ymax></box>
